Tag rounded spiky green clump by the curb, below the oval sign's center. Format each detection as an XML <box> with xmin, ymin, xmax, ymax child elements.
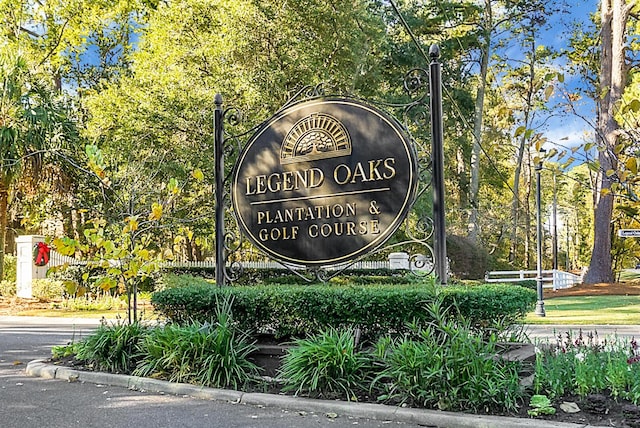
<box><xmin>280</xmin><ymin>329</ymin><xmax>372</xmax><ymax>401</ymax></box>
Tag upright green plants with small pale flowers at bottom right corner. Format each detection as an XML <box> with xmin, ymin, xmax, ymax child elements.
<box><xmin>533</xmin><ymin>330</ymin><xmax>640</xmax><ymax>404</ymax></box>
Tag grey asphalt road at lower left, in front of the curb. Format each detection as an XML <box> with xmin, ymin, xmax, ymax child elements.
<box><xmin>0</xmin><ymin>317</ymin><xmax>419</xmax><ymax>428</ymax></box>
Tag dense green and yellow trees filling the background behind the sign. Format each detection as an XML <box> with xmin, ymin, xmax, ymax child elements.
<box><xmin>0</xmin><ymin>0</ymin><xmax>640</xmax><ymax>280</ymax></box>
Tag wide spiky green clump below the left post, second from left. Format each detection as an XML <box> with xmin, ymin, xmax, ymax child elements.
<box><xmin>134</xmin><ymin>301</ymin><xmax>258</xmax><ymax>389</ymax></box>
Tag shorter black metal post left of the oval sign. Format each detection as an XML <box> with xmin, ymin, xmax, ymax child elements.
<box><xmin>213</xmin><ymin>94</ymin><xmax>225</xmax><ymax>287</ymax></box>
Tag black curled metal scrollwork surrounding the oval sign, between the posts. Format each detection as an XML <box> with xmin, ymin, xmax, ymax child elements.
<box><xmin>215</xmin><ymin>63</ymin><xmax>435</xmax><ymax>282</ymax></box>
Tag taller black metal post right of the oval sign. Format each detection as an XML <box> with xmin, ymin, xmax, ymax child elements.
<box><xmin>429</xmin><ymin>45</ymin><xmax>447</xmax><ymax>284</ymax></box>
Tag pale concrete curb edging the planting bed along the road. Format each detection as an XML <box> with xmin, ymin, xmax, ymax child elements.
<box><xmin>25</xmin><ymin>360</ymin><xmax>595</xmax><ymax>428</ymax></box>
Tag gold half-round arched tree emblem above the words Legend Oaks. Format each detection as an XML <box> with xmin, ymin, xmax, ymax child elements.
<box><xmin>280</xmin><ymin>113</ymin><xmax>351</xmax><ymax>164</ymax></box>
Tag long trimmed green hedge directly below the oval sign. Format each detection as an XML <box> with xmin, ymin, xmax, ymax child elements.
<box><xmin>151</xmin><ymin>278</ymin><xmax>536</xmax><ymax>339</ymax></box>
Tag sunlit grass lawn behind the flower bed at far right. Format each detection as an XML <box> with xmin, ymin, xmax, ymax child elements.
<box><xmin>525</xmin><ymin>296</ymin><xmax>640</xmax><ymax>325</ymax></box>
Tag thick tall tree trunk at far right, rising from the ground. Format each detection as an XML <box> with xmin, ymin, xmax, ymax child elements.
<box><xmin>584</xmin><ymin>0</ymin><xmax>630</xmax><ymax>284</ymax></box>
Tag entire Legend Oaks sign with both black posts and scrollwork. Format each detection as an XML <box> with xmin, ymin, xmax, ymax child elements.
<box><xmin>214</xmin><ymin>45</ymin><xmax>448</xmax><ymax>286</ymax></box>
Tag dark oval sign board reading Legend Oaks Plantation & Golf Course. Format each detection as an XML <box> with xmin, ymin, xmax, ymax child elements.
<box><xmin>232</xmin><ymin>98</ymin><xmax>417</xmax><ymax>266</ymax></box>
